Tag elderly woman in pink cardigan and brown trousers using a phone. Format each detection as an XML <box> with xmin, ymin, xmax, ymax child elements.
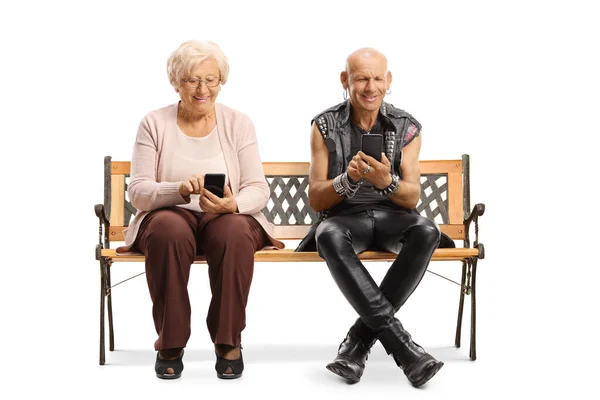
<box><xmin>119</xmin><ymin>41</ymin><xmax>283</xmax><ymax>379</ymax></box>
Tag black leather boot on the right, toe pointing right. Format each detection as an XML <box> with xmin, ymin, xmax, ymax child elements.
<box><xmin>392</xmin><ymin>338</ymin><xmax>444</xmax><ymax>387</ymax></box>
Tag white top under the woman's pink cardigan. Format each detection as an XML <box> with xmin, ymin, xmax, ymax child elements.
<box><xmin>170</xmin><ymin>126</ymin><xmax>229</xmax><ymax>211</ymax></box>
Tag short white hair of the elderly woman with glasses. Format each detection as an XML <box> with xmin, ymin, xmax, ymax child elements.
<box><xmin>167</xmin><ymin>40</ymin><xmax>229</xmax><ymax>92</ymax></box>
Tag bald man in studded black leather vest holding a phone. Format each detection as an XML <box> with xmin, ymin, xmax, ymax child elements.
<box><xmin>297</xmin><ymin>48</ymin><xmax>443</xmax><ymax>387</ymax></box>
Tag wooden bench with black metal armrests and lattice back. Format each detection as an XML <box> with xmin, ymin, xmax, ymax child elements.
<box><xmin>94</xmin><ymin>155</ymin><xmax>485</xmax><ymax>365</ymax></box>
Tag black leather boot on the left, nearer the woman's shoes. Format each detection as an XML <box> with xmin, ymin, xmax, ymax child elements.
<box><xmin>326</xmin><ymin>331</ymin><xmax>377</xmax><ymax>383</ymax></box>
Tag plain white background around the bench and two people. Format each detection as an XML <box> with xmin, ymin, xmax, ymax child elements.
<box><xmin>0</xmin><ymin>0</ymin><xmax>600</xmax><ymax>399</ymax></box>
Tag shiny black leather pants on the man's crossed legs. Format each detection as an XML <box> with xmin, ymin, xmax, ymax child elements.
<box><xmin>316</xmin><ymin>210</ymin><xmax>440</xmax><ymax>354</ymax></box>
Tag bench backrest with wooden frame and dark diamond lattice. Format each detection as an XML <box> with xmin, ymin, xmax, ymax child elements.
<box><xmin>104</xmin><ymin>154</ymin><xmax>471</xmax><ymax>241</ymax></box>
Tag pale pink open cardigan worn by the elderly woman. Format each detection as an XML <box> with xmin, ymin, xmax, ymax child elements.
<box><xmin>117</xmin><ymin>103</ymin><xmax>284</xmax><ymax>253</ymax></box>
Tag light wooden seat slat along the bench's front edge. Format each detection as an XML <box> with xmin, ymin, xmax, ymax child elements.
<box><xmin>101</xmin><ymin>248</ymin><xmax>479</xmax><ymax>264</ymax></box>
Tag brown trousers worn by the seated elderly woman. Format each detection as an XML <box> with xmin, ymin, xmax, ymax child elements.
<box><xmin>134</xmin><ymin>207</ymin><xmax>268</xmax><ymax>350</ymax></box>
